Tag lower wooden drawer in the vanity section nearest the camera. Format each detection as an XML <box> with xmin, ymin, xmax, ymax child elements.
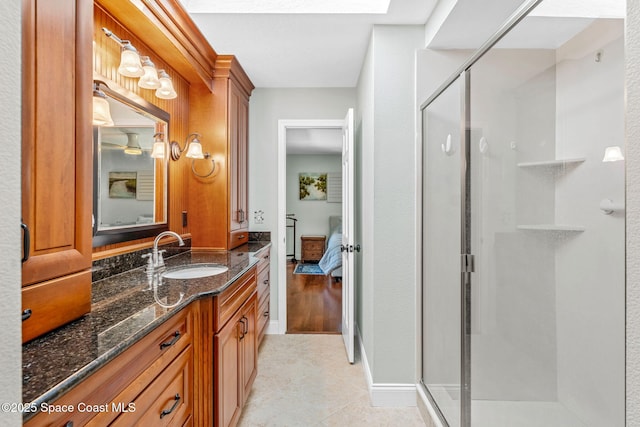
<box><xmin>111</xmin><ymin>346</ymin><xmax>193</xmax><ymax>427</ymax></box>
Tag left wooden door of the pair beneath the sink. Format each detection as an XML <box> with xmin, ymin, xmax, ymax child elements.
<box><xmin>213</xmin><ymin>311</ymin><xmax>243</xmax><ymax>427</ymax></box>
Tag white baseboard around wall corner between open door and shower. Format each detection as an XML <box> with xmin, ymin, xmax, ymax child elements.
<box><xmin>356</xmin><ymin>325</ymin><xmax>417</xmax><ymax>407</ymax></box>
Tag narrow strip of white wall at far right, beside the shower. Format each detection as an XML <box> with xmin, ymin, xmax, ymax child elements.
<box><xmin>625</xmin><ymin>1</ymin><xmax>640</xmax><ymax>426</ymax></box>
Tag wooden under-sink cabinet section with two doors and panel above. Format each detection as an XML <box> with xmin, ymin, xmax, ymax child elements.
<box><xmin>213</xmin><ymin>268</ymin><xmax>258</xmax><ymax>427</ymax></box>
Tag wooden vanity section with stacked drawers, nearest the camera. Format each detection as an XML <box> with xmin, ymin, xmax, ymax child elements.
<box><xmin>25</xmin><ymin>304</ymin><xmax>197</xmax><ymax>427</ymax></box>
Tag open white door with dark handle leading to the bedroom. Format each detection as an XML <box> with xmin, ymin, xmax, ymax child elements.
<box><xmin>342</xmin><ymin>108</ymin><xmax>359</xmax><ymax>363</ymax></box>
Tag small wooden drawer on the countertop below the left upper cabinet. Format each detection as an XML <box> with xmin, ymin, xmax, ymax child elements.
<box><xmin>22</xmin><ymin>270</ymin><xmax>91</xmax><ymax>343</ymax></box>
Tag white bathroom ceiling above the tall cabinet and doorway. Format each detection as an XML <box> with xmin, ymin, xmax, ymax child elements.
<box><xmin>181</xmin><ymin>0</ymin><xmax>437</xmax><ymax>88</ymax></box>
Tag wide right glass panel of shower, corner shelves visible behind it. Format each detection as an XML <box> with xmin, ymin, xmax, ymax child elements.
<box><xmin>468</xmin><ymin>18</ymin><xmax>625</xmax><ymax>427</ymax></box>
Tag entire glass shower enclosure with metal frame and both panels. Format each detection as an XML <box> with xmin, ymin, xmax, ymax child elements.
<box><xmin>422</xmin><ymin>1</ymin><xmax>625</xmax><ymax>427</ymax></box>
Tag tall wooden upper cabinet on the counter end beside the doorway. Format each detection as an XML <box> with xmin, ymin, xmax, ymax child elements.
<box><xmin>189</xmin><ymin>55</ymin><xmax>254</xmax><ymax>249</ymax></box>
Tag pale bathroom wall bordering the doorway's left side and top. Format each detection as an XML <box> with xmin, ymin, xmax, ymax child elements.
<box><xmin>249</xmin><ymin>88</ymin><xmax>356</xmax><ymax>320</ymax></box>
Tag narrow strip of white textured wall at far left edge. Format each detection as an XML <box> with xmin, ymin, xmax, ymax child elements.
<box><xmin>0</xmin><ymin>1</ymin><xmax>22</xmax><ymax>426</ymax></box>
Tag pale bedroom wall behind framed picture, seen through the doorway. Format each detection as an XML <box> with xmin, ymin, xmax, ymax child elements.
<box><xmin>287</xmin><ymin>155</ymin><xmax>342</xmax><ymax>260</ymax></box>
